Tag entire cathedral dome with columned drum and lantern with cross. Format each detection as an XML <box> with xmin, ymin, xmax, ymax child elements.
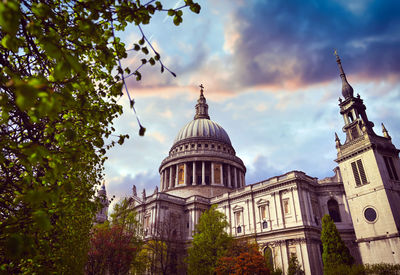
<box><xmin>159</xmin><ymin>89</ymin><xmax>246</xmax><ymax>191</ymax></box>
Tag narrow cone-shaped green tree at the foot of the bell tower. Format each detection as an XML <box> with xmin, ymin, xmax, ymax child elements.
<box><xmin>321</xmin><ymin>214</ymin><xmax>354</xmax><ymax>274</ymax></box>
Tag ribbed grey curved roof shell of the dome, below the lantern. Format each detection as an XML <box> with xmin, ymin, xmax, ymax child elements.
<box><xmin>174</xmin><ymin>118</ymin><xmax>232</xmax><ymax>148</ymax></box>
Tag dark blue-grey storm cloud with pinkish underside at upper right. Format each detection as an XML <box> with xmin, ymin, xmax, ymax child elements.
<box><xmin>233</xmin><ymin>0</ymin><xmax>400</xmax><ymax>85</ymax></box>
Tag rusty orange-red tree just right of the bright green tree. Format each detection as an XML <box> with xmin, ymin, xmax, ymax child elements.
<box><xmin>215</xmin><ymin>241</ymin><xmax>270</xmax><ymax>275</ymax></box>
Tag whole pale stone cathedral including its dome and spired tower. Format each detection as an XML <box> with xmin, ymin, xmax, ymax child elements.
<box><xmin>100</xmin><ymin>55</ymin><xmax>400</xmax><ymax>274</ymax></box>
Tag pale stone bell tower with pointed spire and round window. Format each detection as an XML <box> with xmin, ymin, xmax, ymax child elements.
<box><xmin>335</xmin><ymin>52</ymin><xmax>400</xmax><ymax>264</ymax></box>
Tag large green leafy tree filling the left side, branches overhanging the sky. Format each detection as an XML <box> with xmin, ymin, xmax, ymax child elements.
<box><xmin>0</xmin><ymin>0</ymin><xmax>200</xmax><ymax>274</ymax></box>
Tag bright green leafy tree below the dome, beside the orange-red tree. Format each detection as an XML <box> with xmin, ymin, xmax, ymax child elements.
<box><xmin>187</xmin><ymin>205</ymin><xmax>232</xmax><ymax>275</ymax></box>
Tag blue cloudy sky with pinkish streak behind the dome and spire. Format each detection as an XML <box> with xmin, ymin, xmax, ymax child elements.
<box><xmin>105</xmin><ymin>0</ymin><xmax>400</xmax><ymax>211</ymax></box>
